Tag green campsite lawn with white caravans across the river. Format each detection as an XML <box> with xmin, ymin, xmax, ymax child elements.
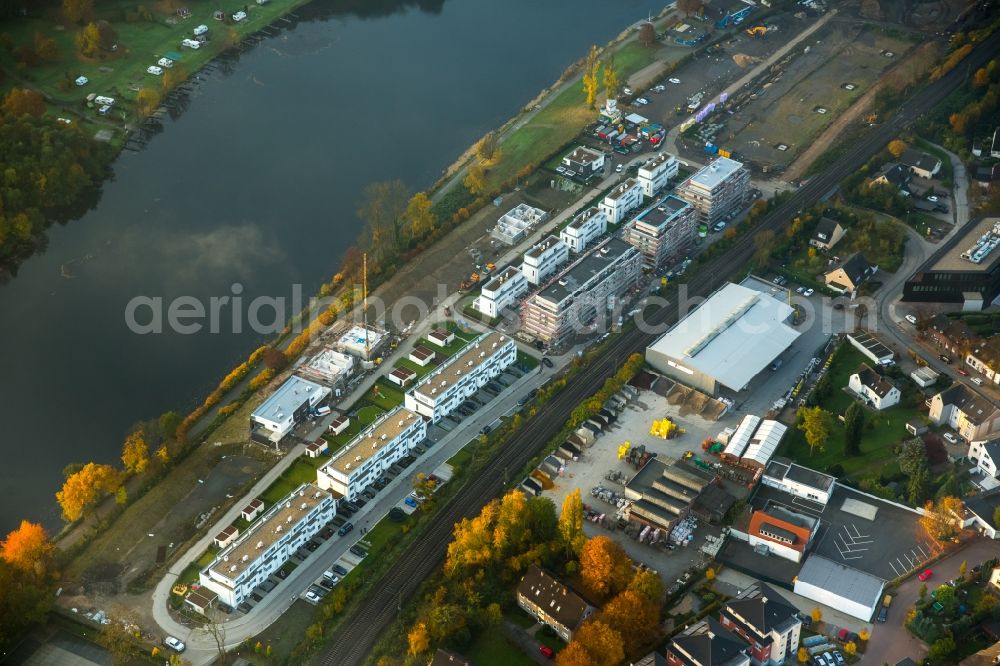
<box><xmin>0</xmin><ymin>0</ymin><xmax>304</xmax><ymax>120</ymax></box>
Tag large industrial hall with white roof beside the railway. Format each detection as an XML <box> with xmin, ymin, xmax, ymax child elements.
<box><xmin>646</xmin><ymin>283</ymin><xmax>799</xmax><ymax>395</ymax></box>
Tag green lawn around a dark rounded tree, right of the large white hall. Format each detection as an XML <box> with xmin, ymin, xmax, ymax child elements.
<box><xmin>778</xmin><ymin>344</ymin><xmax>920</xmax><ymax>479</ymax></box>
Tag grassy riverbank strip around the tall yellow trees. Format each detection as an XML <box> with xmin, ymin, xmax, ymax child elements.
<box><xmin>486</xmin><ymin>40</ymin><xmax>659</xmax><ymax>188</ymax></box>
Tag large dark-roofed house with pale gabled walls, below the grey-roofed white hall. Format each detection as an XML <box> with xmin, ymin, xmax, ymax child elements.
<box><xmin>719</xmin><ymin>583</ymin><xmax>802</xmax><ymax>664</ymax></box>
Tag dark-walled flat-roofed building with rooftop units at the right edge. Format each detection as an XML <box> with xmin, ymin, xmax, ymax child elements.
<box><xmin>903</xmin><ymin>217</ymin><xmax>1000</xmax><ymax>310</ymax></box>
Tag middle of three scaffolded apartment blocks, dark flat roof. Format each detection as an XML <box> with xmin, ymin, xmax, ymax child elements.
<box><xmin>625</xmin><ymin>194</ymin><xmax>698</xmax><ymax>268</ymax></box>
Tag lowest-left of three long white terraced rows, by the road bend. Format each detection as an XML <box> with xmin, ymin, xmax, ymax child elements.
<box><xmin>198</xmin><ymin>483</ymin><xmax>337</xmax><ymax>607</ymax></box>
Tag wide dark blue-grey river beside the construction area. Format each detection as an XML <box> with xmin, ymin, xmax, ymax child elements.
<box><xmin>0</xmin><ymin>0</ymin><xmax>662</xmax><ymax>534</ymax></box>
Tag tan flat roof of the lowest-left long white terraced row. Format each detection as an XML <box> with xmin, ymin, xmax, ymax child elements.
<box><xmin>209</xmin><ymin>483</ymin><xmax>332</xmax><ymax>579</ymax></box>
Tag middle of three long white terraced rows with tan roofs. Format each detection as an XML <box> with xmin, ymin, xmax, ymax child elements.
<box><xmin>316</xmin><ymin>407</ymin><xmax>427</xmax><ymax>501</ymax></box>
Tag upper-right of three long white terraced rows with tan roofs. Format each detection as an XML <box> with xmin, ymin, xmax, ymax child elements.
<box><xmin>405</xmin><ymin>332</ymin><xmax>517</xmax><ymax>423</ymax></box>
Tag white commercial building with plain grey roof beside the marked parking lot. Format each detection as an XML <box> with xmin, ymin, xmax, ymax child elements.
<box><xmin>794</xmin><ymin>553</ymin><xmax>885</xmax><ymax>622</ymax></box>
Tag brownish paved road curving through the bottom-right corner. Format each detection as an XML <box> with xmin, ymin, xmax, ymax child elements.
<box><xmin>861</xmin><ymin>537</ymin><xmax>997</xmax><ymax>666</ymax></box>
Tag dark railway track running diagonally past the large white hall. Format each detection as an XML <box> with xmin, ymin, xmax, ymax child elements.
<box><xmin>317</xmin><ymin>33</ymin><xmax>1000</xmax><ymax>666</ymax></box>
